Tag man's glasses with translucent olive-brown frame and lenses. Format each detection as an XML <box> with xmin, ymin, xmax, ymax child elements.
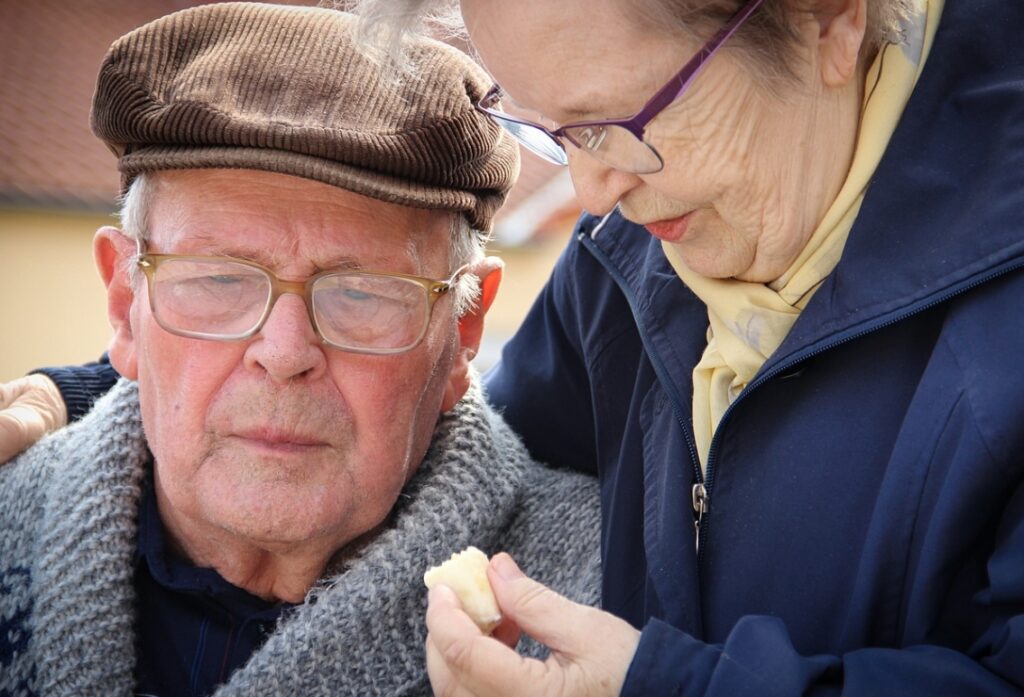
<box><xmin>137</xmin><ymin>243</ymin><xmax>468</xmax><ymax>354</ymax></box>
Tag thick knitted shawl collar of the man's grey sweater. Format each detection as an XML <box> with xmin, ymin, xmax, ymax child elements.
<box><xmin>32</xmin><ymin>380</ymin><xmax>527</xmax><ymax>695</ymax></box>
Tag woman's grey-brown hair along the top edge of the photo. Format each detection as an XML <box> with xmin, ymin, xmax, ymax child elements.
<box><xmin>346</xmin><ymin>0</ymin><xmax>920</xmax><ymax>87</ymax></box>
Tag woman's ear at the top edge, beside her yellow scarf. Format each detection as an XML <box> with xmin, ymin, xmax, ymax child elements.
<box><xmin>817</xmin><ymin>0</ymin><xmax>867</xmax><ymax>87</ymax></box>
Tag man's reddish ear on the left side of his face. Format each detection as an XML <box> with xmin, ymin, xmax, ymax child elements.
<box><xmin>92</xmin><ymin>226</ymin><xmax>138</xmax><ymax>380</ymax></box>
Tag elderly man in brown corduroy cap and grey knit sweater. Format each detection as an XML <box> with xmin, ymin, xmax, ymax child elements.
<box><xmin>0</xmin><ymin>4</ymin><xmax>599</xmax><ymax>695</ymax></box>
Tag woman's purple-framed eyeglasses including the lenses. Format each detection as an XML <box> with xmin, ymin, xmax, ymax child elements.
<box><xmin>476</xmin><ymin>0</ymin><xmax>764</xmax><ymax>174</ymax></box>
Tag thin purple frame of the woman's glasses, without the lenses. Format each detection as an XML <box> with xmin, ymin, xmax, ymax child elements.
<box><xmin>476</xmin><ymin>0</ymin><xmax>764</xmax><ymax>166</ymax></box>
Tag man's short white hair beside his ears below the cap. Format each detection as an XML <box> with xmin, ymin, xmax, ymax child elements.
<box><xmin>118</xmin><ymin>172</ymin><xmax>487</xmax><ymax>317</ymax></box>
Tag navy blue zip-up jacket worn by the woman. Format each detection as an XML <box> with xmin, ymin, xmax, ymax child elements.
<box><xmin>488</xmin><ymin>0</ymin><xmax>1024</xmax><ymax>697</ymax></box>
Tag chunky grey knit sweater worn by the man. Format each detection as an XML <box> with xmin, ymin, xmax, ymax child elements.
<box><xmin>0</xmin><ymin>380</ymin><xmax>600</xmax><ymax>697</ymax></box>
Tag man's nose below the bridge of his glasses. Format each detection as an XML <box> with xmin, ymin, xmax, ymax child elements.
<box><xmin>245</xmin><ymin>293</ymin><xmax>327</xmax><ymax>383</ymax></box>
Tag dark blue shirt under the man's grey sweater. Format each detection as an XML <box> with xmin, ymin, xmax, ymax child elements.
<box><xmin>135</xmin><ymin>485</ymin><xmax>291</xmax><ymax>697</ymax></box>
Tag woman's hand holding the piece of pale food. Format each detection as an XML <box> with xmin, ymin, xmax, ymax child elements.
<box><xmin>426</xmin><ymin>554</ymin><xmax>640</xmax><ymax>697</ymax></box>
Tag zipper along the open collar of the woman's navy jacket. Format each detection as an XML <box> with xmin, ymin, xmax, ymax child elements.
<box><xmin>577</xmin><ymin>220</ymin><xmax>1024</xmax><ymax>568</ymax></box>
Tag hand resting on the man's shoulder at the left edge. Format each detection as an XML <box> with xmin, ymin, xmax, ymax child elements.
<box><xmin>0</xmin><ymin>374</ymin><xmax>68</xmax><ymax>463</ymax></box>
